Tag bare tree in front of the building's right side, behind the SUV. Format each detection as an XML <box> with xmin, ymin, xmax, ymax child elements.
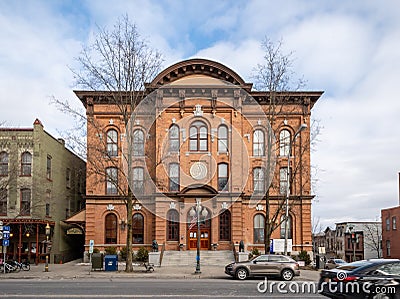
<box><xmin>253</xmin><ymin>37</ymin><xmax>319</xmax><ymax>252</ymax></box>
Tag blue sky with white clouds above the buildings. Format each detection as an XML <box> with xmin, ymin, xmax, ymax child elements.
<box><xmin>0</xmin><ymin>0</ymin><xmax>400</xmax><ymax>230</ymax></box>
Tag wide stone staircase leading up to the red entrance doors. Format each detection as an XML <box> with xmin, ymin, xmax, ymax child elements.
<box><xmin>161</xmin><ymin>250</ymin><xmax>235</xmax><ymax>267</ymax></box>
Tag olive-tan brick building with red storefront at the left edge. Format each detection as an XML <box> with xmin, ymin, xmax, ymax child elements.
<box><xmin>0</xmin><ymin>119</ymin><xmax>85</xmax><ymax>262</ymax></box>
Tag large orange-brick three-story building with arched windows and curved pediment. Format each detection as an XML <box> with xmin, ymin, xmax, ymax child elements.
<box><xmin>75</xmin><ymin>59</ymin><xmax>322</xmax><ymax>258</ymax></box>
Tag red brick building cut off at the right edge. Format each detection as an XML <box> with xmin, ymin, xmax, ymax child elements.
<box><xmin>381</xmin><ymin>206</ymin><xmax>400</xmax><ymax>259</ymax></box>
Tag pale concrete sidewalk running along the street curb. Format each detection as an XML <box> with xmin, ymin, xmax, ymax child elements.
<box><xmin>0</xmin><ymin>261</ymin><xmax>319</xmax><ymax>281</ymax></box>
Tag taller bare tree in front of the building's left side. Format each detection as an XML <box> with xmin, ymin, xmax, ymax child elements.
<box><xmin>53</xmin><ymin>16</ymin><xmax>163</xmax><ymax>272</ymax></box>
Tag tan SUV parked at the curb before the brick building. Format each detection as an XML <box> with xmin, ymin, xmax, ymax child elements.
<box><xmin>225</xmin><ymin>254</ymin><xmax>300</xmax><ymax>281</ymax></box>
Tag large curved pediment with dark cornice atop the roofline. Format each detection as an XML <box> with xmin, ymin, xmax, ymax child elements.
<box><xmin>148</xmin><ymin>58</ymin><xmax>252</xmax><ymax>90</ymax></box>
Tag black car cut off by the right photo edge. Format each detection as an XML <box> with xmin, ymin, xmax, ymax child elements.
<box><xmin>318</xmin><ymin>259</ymin><xmax>400</xmax><ymax>299</ymax></box>
